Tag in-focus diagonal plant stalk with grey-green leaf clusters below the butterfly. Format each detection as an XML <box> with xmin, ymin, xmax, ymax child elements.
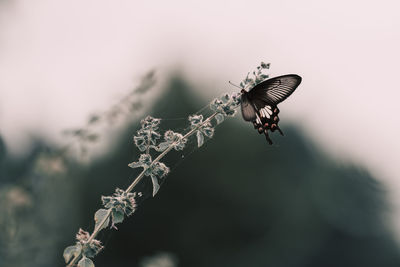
<box><xmin>64</xmin><ymin>64</ymin><xmax>266</xmax><ymax>265</ymax></box>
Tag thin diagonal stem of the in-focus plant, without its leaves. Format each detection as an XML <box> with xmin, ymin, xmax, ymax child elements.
<box><xmin>67</xmin><ymin>112</ymin><xmax>218</xmax><ymax>267</ymax></box>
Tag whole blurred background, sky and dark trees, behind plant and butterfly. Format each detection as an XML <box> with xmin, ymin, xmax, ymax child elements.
<box><xmin>0</xmin><ymin>0</ymin><xmax>400</xmax><ymax>267</ymax></box>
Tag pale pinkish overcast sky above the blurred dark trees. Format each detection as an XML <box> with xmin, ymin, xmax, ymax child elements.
<box><xmin>0</xmin><ymin>0</ymin><xmax>400</xmax><ymax>236</ymax></box>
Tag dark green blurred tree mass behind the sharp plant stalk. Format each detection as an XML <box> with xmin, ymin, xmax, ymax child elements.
<box><xmin>0</xmin><ymin>66</ymin><xmax>400</xmax><ymax>267</ymax></box>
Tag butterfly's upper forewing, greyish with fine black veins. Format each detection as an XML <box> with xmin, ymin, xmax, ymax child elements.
<box><xmin>248</xmin><ymin>74</ymin><xmax>301</xmax><ymax>105</ymax></box>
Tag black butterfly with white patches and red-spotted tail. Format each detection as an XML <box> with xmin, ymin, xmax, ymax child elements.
<box><xmin>241</xmin><ymin>74</ymin><xmax>301</xmax><ymax>145</ymax></box>
